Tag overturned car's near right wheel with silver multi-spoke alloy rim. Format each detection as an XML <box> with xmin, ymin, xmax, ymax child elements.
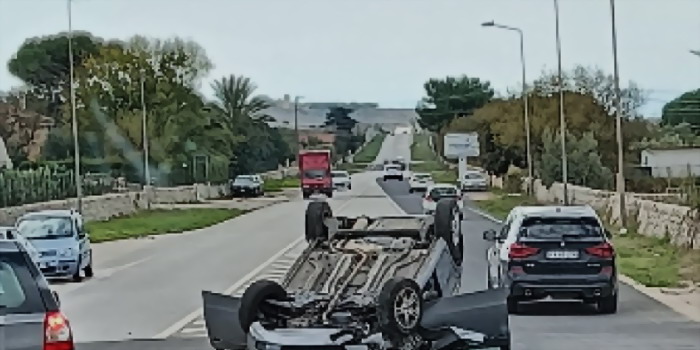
<box><xmin>377</xmin><ymin>277</ymin><xmax>423</xmax><ymax>345</ymax></box>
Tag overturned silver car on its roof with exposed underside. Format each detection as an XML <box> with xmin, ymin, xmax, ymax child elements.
<box><xmin>202</xmin><ymin>199</ymin><xmax>510</xmax><ymax>350</ymax></box>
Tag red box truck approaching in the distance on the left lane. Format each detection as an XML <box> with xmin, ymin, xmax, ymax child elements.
<box><xmin>299</xmin><ymin>150</ymin><xmax>333</xmax><ymax>198</ymax></box>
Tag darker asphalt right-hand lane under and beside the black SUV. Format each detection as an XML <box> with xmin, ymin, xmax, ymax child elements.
<box><xmin>378</xmin><ymin>181</ymin><xmax>700</xmax><ymax>350</ymax></box>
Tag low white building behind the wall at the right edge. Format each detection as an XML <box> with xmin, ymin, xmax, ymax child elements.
<box><xmin>641</xmin><ymin>147</ymin><xmax>700</xmax><ymax>178</ymax></box>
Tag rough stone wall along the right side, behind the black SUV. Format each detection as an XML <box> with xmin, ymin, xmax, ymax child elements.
<box><xmin>534</xmin><ymin>180</ymin><xmax>700</xmax><ymax>249</ymax></box>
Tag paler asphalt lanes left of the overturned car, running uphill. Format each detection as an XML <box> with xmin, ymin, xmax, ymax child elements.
<box><xmin>65</xmin><ymin>135</ymin><xmax>412</xmax><ymax>349</ymax></box>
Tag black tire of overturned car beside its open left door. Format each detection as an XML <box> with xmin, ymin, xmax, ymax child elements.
<box><xmin>238</xmin><ymin>280</ymin><xmax>287</xmax><ymax>334</ymax></box>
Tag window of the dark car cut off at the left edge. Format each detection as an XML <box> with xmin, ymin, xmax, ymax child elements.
<box><xmin>0</xmin><ymin>253</ymin><xmax>45</xmax><ymax>314</ymax></box>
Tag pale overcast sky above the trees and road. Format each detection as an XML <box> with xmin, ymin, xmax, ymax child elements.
<box><xmin>0</xmin><ymin>0</ymin><xmax>700</xmax><ymax>116</ymax></box>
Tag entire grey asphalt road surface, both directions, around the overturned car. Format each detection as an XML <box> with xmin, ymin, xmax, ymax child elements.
<box><xmin>68</xmin><ymin>130</ymin><xmax>700</xmax><ymax>350</ymax></box>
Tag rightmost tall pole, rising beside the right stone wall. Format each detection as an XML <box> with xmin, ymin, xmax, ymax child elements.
<box><xmin>610</xmin><ymin>0</ymin><xmax>627</xmax><ymax>228</ymax></box>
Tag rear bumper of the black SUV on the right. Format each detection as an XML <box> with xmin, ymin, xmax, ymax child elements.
<box><xmin>510</xmin><ymin>275</ymin><xmax>617</xmax><ymax>299</ymax></box>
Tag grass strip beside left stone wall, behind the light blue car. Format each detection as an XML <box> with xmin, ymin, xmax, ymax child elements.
<box><xmin>87</xmin><ymin>208</ymin><xmax>245</xmax><ymax>243</ymax></box>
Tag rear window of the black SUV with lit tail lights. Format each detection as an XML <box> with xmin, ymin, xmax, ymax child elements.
<box><xmin>519</xmin><ymin>217</ymin><xmax>604</xmax><ymax>239</ymax></box>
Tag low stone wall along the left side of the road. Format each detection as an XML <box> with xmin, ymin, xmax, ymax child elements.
<box><xmin>0</xmin><ymin>184</ymin><xmax>228</xmax><ymax>225</ymax></box>
